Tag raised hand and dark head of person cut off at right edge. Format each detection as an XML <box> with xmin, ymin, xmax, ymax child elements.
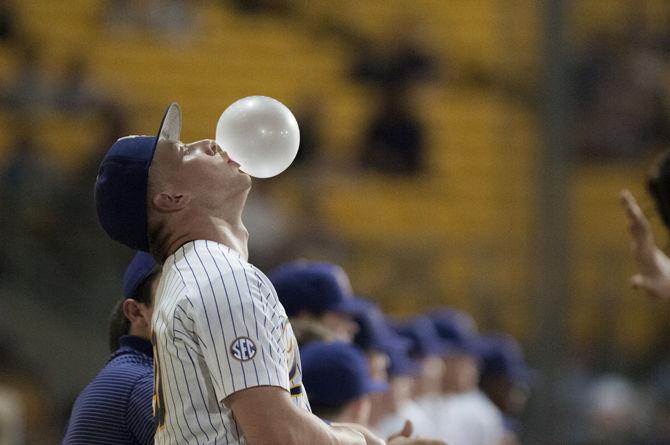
<box><xmin>620</xmin><ymin>150</ymin><xmax>670</xmax><ymax>301</ymax></box>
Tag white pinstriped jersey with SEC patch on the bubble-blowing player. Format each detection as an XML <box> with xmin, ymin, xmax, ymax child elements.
<box><xmin>152</xmin><ymin>240</ymin><xmax>310</xmax><ymax>444</ymax></box>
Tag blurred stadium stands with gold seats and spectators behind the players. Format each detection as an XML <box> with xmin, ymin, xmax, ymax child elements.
<box><xmin>0</xmin><ymin>0</ymin><xmax>670</xmax><ymax>443</ymax></box>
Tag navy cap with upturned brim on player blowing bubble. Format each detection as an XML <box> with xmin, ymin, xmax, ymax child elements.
<box><xmin>95</xmin><ymin>103</ymin><xmax>181</xmax><ymax>252</ymax></box>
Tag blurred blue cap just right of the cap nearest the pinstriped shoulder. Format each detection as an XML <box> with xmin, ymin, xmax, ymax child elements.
<box><xmin>354</xmin><ymin>297</ymin><xmax>410</xmax><ymax>354</ymax></box>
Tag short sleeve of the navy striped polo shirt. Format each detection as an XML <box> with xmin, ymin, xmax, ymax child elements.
<box><xmin>127</xmin><ymin>372</ymin><xmax>156</xmax><ymax>445</ymax></box>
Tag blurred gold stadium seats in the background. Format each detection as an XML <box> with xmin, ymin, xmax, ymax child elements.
<box><xmin>7</xmin><ymin>0</ymin><xmax>668</xmax><ymax>354</ymax></box>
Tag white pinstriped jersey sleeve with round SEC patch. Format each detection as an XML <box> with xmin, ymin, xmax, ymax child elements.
<box><xmin>194</xmin><ymin>253</ymin><xmax>290</xmax><ymax>402</ymax></box>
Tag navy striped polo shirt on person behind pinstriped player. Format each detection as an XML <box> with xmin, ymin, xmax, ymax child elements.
<box><xmin>63</xmin><ymin>335</ymin><xmax>156</xmax><ymax>445</ymax></box>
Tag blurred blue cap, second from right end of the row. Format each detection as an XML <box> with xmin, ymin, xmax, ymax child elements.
<box><xmin>428</xmin><ymin>309</ymin><xmax>481</xmax><ymax>357</ymax></box>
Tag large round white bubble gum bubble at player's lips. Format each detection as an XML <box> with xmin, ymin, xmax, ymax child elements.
<box><xmin>216</xmin><ymin>96</ymin><xmax>300</xmax><ymax>178</ymax></box>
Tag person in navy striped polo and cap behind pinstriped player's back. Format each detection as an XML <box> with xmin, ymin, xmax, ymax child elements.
<box><xmin>63</xmin><ymin>252</ymin><xmax>160</xmax><ymax>445</ymax></box>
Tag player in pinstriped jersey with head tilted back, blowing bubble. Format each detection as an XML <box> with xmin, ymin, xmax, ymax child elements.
<box><xmin>95</xmin><ymin>104</ymin><xmax>394</xmax><ymax>445</ymax></box>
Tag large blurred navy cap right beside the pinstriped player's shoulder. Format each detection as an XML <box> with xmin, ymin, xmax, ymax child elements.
<box><xmin>268</xmin><ymin>261</ymin><xmax>368</xmax><ymax>317</ymax></box>
